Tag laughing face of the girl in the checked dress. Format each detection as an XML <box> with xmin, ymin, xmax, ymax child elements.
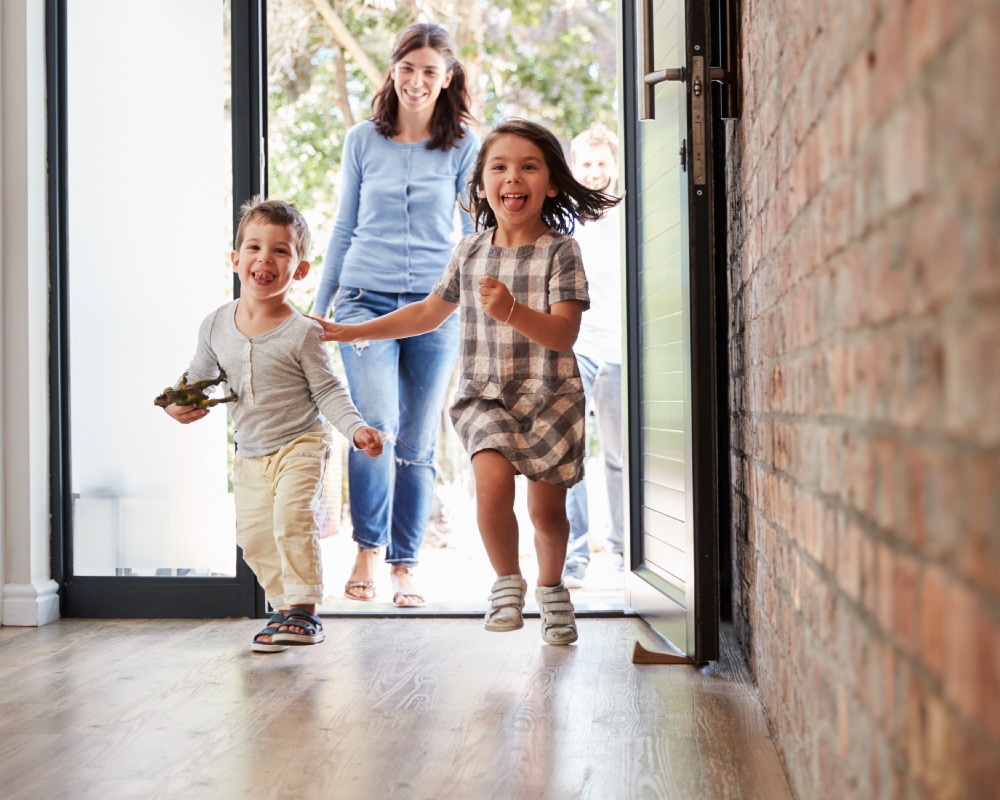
<box><xmin>479</xmin><ymin>133</ymin><xmax>559</xmax><ymax>234</ymax></box>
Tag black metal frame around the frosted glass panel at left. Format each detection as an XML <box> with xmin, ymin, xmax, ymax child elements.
<box><xmin>45</xmin><ymin>0</ymin><xmax>267</xmax><ymax>619</ymax></box>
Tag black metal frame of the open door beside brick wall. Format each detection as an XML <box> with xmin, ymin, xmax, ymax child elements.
<box><xmin>618</xmin><ymin>0</ymin><xmax>736</xmax><ymax>662</ymax></box>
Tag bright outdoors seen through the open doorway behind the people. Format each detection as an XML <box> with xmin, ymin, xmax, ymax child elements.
<box><xmin>267</xmin><ymin>0</ymin><xmax>624</xmax><ymax>614</ymax></box>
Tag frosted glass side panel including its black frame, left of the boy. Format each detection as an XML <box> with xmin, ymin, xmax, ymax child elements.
<box><xmin>54</xmin><ymin>0</ymin><xmax>254</xmax><ymax>617</ymax></box>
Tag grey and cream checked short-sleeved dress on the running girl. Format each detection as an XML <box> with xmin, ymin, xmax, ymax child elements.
<box><xmin>432</xmin><ymin>228</ymin><xmax>590</xmax><ymax>488</ymax></box>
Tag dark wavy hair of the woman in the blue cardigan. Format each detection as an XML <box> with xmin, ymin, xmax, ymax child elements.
<box><xmin>371</xmin><ymin>22</ymin><xmax>473</xmax><ymax>152</ymax></box>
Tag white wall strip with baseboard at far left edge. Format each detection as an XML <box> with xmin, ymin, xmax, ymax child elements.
<box><xmin>0</xmin><ymin>0</ymin><xmax>59</xmax><ymax>625</ymax></box>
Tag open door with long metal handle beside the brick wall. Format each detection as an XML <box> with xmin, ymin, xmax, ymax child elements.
<box><xmin>622</xmin><ymin>0</ymin><xmax>718</xmax><ymax>661</ymax></box>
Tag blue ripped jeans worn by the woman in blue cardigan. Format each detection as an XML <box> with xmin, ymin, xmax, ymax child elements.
<box><xmin>334</xmin><ymin>286</ymin><xmax>459</xmax><ymax>567</ymax></box>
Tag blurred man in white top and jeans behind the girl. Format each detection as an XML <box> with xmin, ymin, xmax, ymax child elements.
<box><xmin>563</xmin><ymin>124</ymin><xmax>624</xmax><ymax>589</ymax></box>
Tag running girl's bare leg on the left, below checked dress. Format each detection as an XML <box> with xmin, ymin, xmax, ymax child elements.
<box><xmin>472</xmin><ymin>450</ymin><xmax>520</xmax><ymax>582</ymax></box>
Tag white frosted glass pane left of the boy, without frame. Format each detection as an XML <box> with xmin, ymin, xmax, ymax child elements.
<box><xmin>67</xmin><ymin>0</ymin><xmax>236</xmax><ymax>576</ymax></box>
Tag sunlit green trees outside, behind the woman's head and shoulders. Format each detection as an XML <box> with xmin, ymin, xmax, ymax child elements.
<box><xmin>267</xmin><ymin>0</ymin><xmax>617</xmax><ymax>310</ymax></box>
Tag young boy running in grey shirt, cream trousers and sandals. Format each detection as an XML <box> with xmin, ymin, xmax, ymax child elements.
<box><xmin>166</xmin><ymin>197</ymin><xmax>382</xmax><ymax>653</ymax></box>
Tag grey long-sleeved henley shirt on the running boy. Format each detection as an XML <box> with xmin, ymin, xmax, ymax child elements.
<box><xmin>188</xmin><ymin>300</ymin><xmax>365</xmax><ymax>458</ymax></box>
